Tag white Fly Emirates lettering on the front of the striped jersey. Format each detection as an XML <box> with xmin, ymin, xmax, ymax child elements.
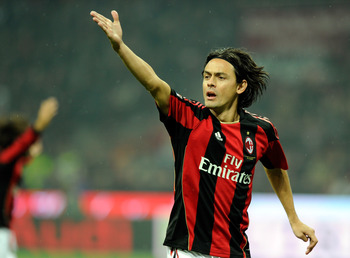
<box><xmin>199</xmin><ymin>154</ymin><xmax>252</xmax><ymax>185</ymax></box>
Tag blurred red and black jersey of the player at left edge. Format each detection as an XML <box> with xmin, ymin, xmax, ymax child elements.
<box><xmin>0</xmin><ymin>128</ymin><xmax>39</xmax><ymax>228</ymax></box>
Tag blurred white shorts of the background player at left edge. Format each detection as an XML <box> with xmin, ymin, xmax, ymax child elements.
<box><xmin>0</xmin><ymin>228</ymin><xmax>17</xmax><ymax>258</ymax></box>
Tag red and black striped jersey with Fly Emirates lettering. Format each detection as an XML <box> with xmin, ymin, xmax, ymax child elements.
<box><xmin>160</xmin><ymin>90</ymin><xmax>288</xmax><ymax>257</ymax></box>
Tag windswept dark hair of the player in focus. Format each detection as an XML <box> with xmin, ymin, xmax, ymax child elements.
<box><xmin>204</xmin><ymin>48</ymin><xmax>269</xmax><ymax>109</ymax></box>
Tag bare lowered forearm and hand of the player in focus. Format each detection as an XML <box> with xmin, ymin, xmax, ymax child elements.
<box><xmin>264</xmin><ymin>167</ymin><xmax>318</xmax><ymax>254</ymax></box>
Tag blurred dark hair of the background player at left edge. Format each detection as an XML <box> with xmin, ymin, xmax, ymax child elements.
<box><xmin>0</xmin><ymin>114</ymin><xmax>29</xmax><ymax>150</ymax></box>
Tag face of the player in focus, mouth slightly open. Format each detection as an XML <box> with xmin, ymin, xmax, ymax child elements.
<box><xmin>203</xmin><ymin>58</ymin><xmax>245</xmax><ymax>114</ymax></box>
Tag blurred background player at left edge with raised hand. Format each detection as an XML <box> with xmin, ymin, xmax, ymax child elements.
<box><xmin>0</xmin><ymin>98</ymin><xmax>58</xmax><ymax>258</ymax></box>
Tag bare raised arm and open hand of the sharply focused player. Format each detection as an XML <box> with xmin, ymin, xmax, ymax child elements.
<box><xmin>90</xmin><ymin>10</ymin><xmax>170</xmax><ymax>114</ymax></box>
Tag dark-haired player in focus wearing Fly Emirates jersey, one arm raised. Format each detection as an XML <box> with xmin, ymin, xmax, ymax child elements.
<box><xmin>91</xmin><ymin>11</ymin><xmax>317</xmax><ymax>258</ymax></box>
